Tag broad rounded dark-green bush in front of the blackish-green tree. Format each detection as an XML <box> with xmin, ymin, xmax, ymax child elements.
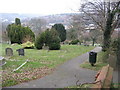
<box><xmin>35</xmin><ymin>29</ymin><xmax>60</xmax><ymax>50</ymax></box>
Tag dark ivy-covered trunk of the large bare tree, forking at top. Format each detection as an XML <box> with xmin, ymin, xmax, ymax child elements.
<box><xmin>102</xmin><ymin>1</ymin><xmax>120</xmax><ymax>51</ymax></box>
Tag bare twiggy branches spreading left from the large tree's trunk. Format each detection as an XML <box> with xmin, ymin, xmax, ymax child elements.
<box><xmin>79</xmin><ymin>0</ymin><xmax>107</xmax><ymax>31</ymax></box>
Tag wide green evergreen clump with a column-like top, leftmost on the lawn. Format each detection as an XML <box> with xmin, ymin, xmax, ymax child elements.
<box><xmin>6</xmin><ymin>19</ymin><xmax>35</xmax><ymax>44</ymax></box>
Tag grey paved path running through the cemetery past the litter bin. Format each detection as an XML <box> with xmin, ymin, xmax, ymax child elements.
<box><xmin>10</xmin><ymin>47</ymin><xmax>101</xmax><ymax>88</ymax></box>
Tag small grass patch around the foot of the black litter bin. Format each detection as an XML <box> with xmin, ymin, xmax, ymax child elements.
<box><xmin>80</xmin><ymin>51</ymin><xmax>108</xmax><ymax>71</ymax></box>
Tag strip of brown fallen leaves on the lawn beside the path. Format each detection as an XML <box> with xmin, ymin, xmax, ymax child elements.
<box><xmin>2</xmin><ymin>67</ymin><xmax>54</xmax><ymax>86</ymax></box>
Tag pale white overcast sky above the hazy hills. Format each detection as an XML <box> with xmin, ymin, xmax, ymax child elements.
<box><xmin>0</xmin><ymin>0</ymin><xmax>82</xmax><ymax>15</ymax></box>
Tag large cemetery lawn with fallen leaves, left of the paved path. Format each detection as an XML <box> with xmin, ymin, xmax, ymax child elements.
<box><xmin>2</xmin><ymin>44</ymin><xmax>94</xmax><ymax>87</ymax></box>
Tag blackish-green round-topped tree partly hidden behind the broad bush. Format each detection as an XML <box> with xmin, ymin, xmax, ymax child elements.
<box><xmin>52</xmin><ymin>24</ymin><xmax>66</xmax><ymax>42</ymax></box>
